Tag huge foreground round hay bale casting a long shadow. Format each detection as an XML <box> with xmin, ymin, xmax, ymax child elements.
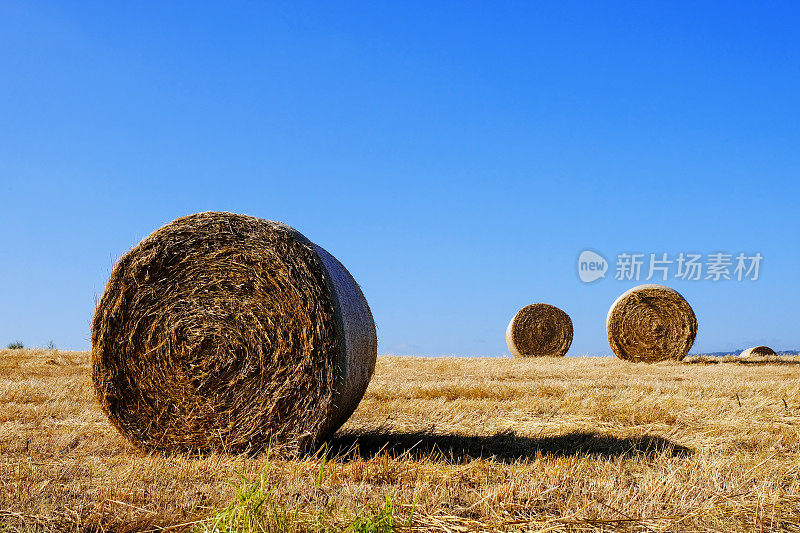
<box><xmin>92</xmin><ymin>212</ymin><xmax>377</xmax><ymax>452</ymax></box>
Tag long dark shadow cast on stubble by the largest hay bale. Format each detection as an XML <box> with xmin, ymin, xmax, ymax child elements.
<box><xmin>328</xmin><ymin>430</ymin><xmax>694</xmax><ymax>463</ymax></box>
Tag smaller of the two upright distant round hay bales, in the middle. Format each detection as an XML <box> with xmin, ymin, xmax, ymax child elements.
<box><xmin>506</xmin><ymin>304</ymin><xmax>572</xmax><ymax>357</ymax></box>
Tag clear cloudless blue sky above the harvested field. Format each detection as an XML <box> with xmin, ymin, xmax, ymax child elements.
<box><xmin>0</xmin><ymin>0</ymin><xmax>800</xmax><ymax>355</ymax></box>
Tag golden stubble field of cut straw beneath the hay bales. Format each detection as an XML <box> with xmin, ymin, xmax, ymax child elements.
<box><xmin>0</xmin><ymin>350</ymin><xmax>800</xmax><ymax>531</ymax></box>
